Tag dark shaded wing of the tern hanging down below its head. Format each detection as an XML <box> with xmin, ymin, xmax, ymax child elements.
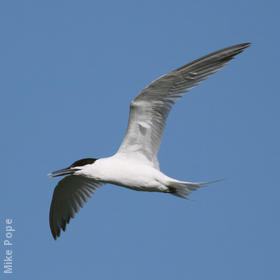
<box><xmin>49</xmin><ymin>175</ymin><xmax>103</xmax><ymax>239</ymax></box>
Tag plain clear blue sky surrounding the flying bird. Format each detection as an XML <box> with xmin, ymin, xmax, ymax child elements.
<box><xmin>0</xmin><ymin>0</ymin><xmax>280</xmax><ymax>280</ymax></box>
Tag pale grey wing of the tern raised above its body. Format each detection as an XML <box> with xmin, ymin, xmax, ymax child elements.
<box><xmin>118</xmin><ymin>43</ymin><xmax>250</xmax><ymax>168</ymax></box>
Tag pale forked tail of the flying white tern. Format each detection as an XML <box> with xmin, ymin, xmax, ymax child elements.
<box><xmin>168</xmin><ymin>180</ymin><xmax>221</xmax><ymax>199</ymax></box>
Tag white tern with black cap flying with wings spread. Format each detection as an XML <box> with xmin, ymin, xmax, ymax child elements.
<box><xmin>49</xmin><ymin>43</ymin><xmax>250</xmax><ymax>239</ymax></box>
